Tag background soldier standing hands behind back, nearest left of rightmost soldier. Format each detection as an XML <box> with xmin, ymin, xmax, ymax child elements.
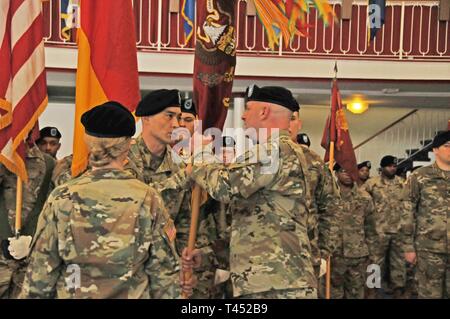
<box><xmin>363</xmin><ymin>155</ymin><xmax>406</xmax><ymax>298</ymax></box>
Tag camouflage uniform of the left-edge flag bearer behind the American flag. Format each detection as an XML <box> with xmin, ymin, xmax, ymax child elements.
<box><xmin>0</xmin><ymin>145</ymin><xmax>54</xmax><ymax>298</ymax></box>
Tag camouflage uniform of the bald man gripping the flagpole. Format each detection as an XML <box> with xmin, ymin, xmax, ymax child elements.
<box><xmin>191</xmin><ymin>131</ymin><xmax>335</xmax><ymax>298</ymax></box>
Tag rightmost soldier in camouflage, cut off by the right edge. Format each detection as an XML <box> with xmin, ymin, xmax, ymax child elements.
<box><xmin>402</xmin><ymin>131</ymin><xmax>450</xmax><ymax>298</ymax></box>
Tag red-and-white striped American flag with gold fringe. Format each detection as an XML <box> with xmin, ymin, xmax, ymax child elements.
<box><xmin>0</xmin><ymin>0</ymin><xmax>48</xmax><ymax>181</ymax></box>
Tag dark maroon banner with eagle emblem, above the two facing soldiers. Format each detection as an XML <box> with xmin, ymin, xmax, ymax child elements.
<box><xmin>194</xmin><ymin>0</ymin><xmax>236</xmax><ymax>130</ymax></box>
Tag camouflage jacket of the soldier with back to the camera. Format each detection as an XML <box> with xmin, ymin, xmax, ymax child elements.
<box><xmin>20</xmin><ymin>169</ymin><xmax>181</xmax><ymax>298</ymax></box>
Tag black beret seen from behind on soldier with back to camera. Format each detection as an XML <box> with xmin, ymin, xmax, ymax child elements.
<box><xmin>81</xmin><ymin>101</ymin><xmax>136</xmax><ymax>138</ymax></box>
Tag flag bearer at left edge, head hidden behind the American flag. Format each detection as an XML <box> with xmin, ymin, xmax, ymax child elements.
<box><xmin>0</xmin><ymin>144</ymin><xmax>54</xmax><ymax>298</ymax></box>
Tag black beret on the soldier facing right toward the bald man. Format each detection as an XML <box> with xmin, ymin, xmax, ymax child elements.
<box><xmin>136</xmin><ymin>89</ymin><xmax>181</xmax><ymax>116</ymax></box>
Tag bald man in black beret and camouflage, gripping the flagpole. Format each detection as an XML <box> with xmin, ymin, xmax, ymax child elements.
<box><xmin>191</xmin><ymin>85</ymin><xmax>337</xmax><ymax>298</ymax></box>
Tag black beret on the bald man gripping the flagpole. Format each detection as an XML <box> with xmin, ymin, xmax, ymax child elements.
<box><xmin>246</xmin><ymin>85</ymin><xmax>300</xmax><ymax>112</ymax></box>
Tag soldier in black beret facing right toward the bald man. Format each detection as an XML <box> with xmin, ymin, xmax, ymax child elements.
<box><xmin>126</xmin><ymin>89</ymin><xmax>191</xmax><ymax>254</ymax></box>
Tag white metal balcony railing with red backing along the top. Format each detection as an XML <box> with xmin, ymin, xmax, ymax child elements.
<box><xmin>44</xmin><ymin>0</ymin><xmax>450</xmax><ymax>61</ymax></box>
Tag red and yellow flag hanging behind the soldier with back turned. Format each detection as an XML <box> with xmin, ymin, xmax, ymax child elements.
<box><xmin>72</xmin><ymin>0</ymin><xmax>140</xmax><ymax>176</ymax></box>
